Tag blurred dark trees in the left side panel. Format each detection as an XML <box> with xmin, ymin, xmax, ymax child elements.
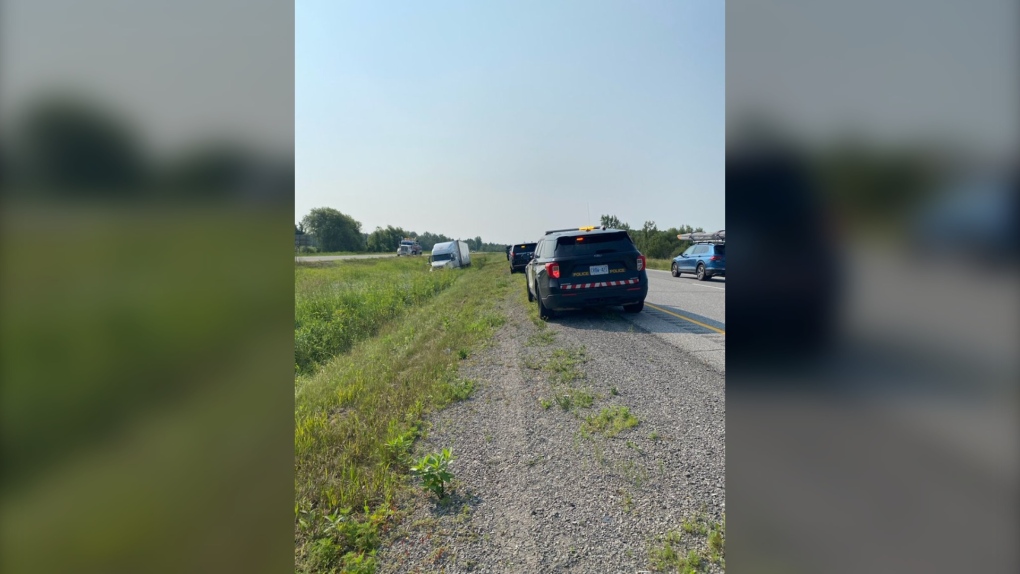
<box><xmin>6</xmin><ymin>93</ymin><xmax>294</xmax><ymax>202</ymax></box>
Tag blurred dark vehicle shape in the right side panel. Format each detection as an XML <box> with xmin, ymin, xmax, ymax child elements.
<box><xmin>726</xmin><ymin>149</ymin><xmax>845</xmax><ymax>373</ymax></box>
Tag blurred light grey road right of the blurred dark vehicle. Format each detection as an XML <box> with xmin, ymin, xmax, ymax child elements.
<box><xmin>839</xmin><ymin>246</ymin><xmax>1020</xmax><ymax>381</ymax></box>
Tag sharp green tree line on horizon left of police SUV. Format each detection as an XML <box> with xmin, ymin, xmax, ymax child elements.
<box><xmin>294</xmin><ymin>207</ymin><xmax>506</xmax><ymax>253</ymax></box>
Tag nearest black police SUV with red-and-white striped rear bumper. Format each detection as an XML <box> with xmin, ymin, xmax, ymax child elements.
<box><xmin>526</xmin><ymin>227</ymin><xmax>648</xmax><ymax>320</ymax></box>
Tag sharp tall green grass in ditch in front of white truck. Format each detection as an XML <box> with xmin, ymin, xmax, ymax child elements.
<box><xmin>294</xmin><ymin>258</ymin><xmax>459</xmax><ymax>373</ymax></box>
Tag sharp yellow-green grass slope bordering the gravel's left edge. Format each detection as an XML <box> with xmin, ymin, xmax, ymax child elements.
<box><xmin>295</xmin><ymin>255</ymin><xmax>511</xmax><ymax>572</ymax></box>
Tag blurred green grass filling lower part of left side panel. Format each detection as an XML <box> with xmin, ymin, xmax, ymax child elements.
<box><xmin>0</xmin><ymin>203</ymin><xmax>294</xmax><ymax>572</ymax></box>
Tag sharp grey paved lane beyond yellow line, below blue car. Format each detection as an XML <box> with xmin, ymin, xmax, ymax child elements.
<box><xmin>645</xmin><ymin>269</ymin><xmax>726</xmax><ymax>326</ymax></box>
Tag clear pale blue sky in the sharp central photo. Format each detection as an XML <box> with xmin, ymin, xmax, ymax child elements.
<box><xmin>295</xmin><ymin>0</ymin><xmax>725</xmax><ymax>244</ymax></box>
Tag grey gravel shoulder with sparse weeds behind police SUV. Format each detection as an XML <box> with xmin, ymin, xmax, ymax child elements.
<box><xmin>378</xmin><ymin>285</ymin><xmax>725</xmax><ymax>573</ymax></box>
